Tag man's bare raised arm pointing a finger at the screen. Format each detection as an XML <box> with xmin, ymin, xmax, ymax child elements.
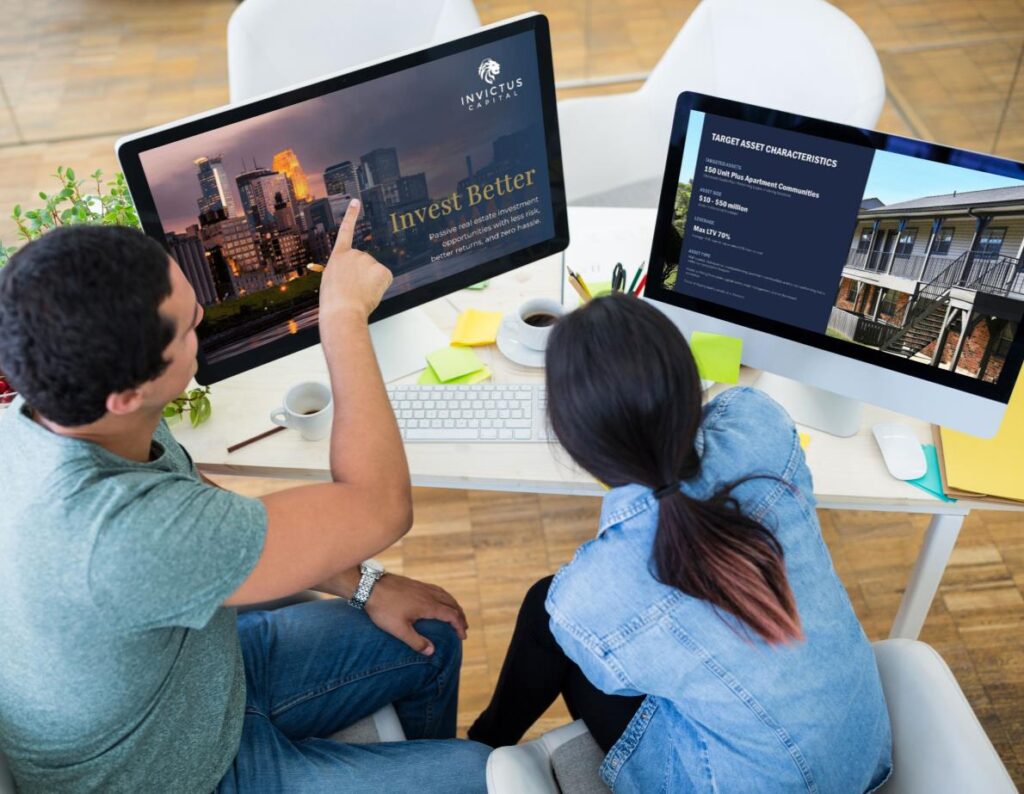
<box><xmin>225</xmin><ymin>201</ymin><xmax>413</xmax><ymax>605</ymax></box>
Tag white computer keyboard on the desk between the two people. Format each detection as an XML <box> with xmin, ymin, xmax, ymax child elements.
<box><xmin>387</xmin><ymin>383</ymin><xmax>553</xmax><ymax>444</ymax></box>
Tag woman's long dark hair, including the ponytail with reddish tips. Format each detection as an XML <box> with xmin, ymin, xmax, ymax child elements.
<box><xmin>546</xmin><ymin>294</ymin><xmax>802</xmax><ymax>643</ymax></box>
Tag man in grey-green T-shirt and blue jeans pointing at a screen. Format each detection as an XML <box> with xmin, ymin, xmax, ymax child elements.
<box><xmin>0</xmin><ymin>202</ymin><xmax>487</xmax><ymax>792</ymax></box>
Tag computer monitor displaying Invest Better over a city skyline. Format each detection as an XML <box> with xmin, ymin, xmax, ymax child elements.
<box><xmin>117</xmin><ymin>14</ymin><xmax>568</xmax><ymax>383</ymax></box>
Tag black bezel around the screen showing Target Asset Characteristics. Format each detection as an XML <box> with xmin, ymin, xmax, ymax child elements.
<box><xmin>644</xmin><ymin>91</ymin><xmax>1024</xmax><ymax>404</ymax></box>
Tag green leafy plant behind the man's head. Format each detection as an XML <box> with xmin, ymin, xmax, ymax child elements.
<box><xmin>0</xmin><ymin>166</ymin><xmax>211</xmax><ymax>426</ymax></box>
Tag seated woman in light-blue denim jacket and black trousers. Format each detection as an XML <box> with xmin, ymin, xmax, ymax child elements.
<box><xmin>469</xmin><ymin>295</ymin><xmax>891</xmax><ymax>794</ymax></box>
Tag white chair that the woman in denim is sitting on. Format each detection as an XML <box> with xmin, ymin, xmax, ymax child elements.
<box><xmin>487</xmin><ymin>639</ymin><xmax>1017</xmax><ymax>794</ymax></box>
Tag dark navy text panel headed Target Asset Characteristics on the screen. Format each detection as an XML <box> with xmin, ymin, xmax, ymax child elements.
<box><xmin>676</xmin><ymin>114</ymin><xmax>874</xmax><ymax>332</ymax></box>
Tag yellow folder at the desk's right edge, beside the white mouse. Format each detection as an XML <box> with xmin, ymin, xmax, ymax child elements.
<box><xmin>940</xmin><ymin>385</ymin><xmax>1024</xmax><ymax>500</ymax></box>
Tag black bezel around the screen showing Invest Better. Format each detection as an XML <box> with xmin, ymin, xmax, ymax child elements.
<box><xmin>116</xmin><ymin>13</ymin><xmax>569</xmax><ymax>385</ymax></box>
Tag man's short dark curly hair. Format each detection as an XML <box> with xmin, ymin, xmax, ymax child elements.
<box><xmin>0</xmin><ymin>225</ymin><xmax>175</xmax><ymax>427</ymax></box>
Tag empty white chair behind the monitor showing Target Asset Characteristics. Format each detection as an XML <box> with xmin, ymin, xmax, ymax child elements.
<box><xmin>558</xmin><ymin>0</ymin><xmax>886</xmax><ymax>207</ymax></box>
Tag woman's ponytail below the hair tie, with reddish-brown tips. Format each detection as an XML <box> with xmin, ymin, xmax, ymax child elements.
<box><xmin>652</xmin><ymin>483</ymin><xmax>803</xmax><ymax>644</ymax></box>
